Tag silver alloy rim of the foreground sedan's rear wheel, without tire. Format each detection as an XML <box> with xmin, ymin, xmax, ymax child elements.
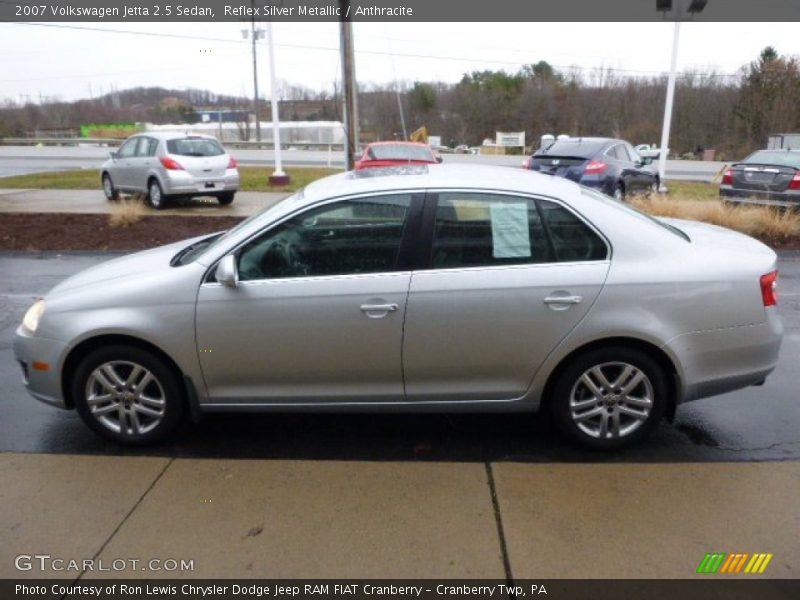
<box><xmin>569</xmin><ymin>362</ymin><xmax>654</xmax><ymax>439</ymax></box>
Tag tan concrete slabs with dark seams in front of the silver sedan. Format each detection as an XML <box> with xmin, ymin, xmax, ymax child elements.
<box><xmin>0</xmin><ymin>453</ymin><xmax>800</xmax><ymax>579</ymax></box>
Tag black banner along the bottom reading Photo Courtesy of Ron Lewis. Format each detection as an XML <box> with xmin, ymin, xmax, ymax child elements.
<box><xmin>0</xmin><ymin>575</ymin><xmax>800</xmax><ymax>600</ymax></box>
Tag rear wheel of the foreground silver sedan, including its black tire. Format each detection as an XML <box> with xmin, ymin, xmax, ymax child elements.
<box><xmin>546</xmin><ymin>346</ymin><xmax>669</xmax><ymax>450</ymax></box>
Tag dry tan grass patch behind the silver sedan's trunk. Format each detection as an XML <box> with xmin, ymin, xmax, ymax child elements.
<box><xmin>631</xmin><ymin>195</ymin><xmax>800</xmax><ymax>244</ymax></box>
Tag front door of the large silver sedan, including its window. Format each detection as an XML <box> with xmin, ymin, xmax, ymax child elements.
<box><xmin>196</xmin><ymin>194</ymin><xmax>416</xmax><ymax>405</ymax></box>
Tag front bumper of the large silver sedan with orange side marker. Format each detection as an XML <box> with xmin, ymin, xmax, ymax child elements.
<box><xmin>14</xmin><ymin>327</ymin><xmax>69</xmax><ymax>408</ymax></box>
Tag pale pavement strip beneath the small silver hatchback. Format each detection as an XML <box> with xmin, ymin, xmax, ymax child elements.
<box><xmin>0</xmin><ymin>189</ymin><xmax>289</xmax><ymax>217</ymax></box>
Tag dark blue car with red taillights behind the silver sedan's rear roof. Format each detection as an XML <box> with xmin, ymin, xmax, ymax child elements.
<box><xmin>526</xmin><ymin>137</ymin><xmax>659</xmax><ymax>200</ymax></box>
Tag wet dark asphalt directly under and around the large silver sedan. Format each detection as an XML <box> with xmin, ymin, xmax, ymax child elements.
<box><xmin>0</xmin><ymin>253</ymin><xmax>800</xmax><ymax>463</ymax></box>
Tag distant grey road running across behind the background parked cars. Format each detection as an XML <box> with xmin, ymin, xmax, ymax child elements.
<box><xmin>0</xmin><ymin>146</ymin><xmax>725</xmax><ymax>181</ymax></box>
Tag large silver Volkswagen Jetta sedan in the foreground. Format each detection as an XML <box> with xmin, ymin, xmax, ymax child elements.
<box><xmin>14</xmin><ymin>165</ymin><xmax>782</xmax><ymax>448</ymax></box>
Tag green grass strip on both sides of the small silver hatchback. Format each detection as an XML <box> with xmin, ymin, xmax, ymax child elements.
<box><xmin>0</xmin><ymin>167</ymin><xmax>341</xmax><ymax>192</ymax></box>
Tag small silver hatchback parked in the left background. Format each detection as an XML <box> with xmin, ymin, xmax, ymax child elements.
<box><xmin>100</xmin><ymin>132</ymin><xmax>239</xmax><ymax>209</ymax></box>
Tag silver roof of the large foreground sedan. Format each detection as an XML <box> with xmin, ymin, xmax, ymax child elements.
<box><xmin>296</xmin><ymin>164</ymin><xmax>579</xmax><ymax>208</ymax></box>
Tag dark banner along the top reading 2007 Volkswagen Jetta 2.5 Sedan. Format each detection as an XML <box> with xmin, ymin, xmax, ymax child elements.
<box><xmin>0</xmin><ymin>0</ymin><xmax>800</xmax><ymax>23</ymax></box>
